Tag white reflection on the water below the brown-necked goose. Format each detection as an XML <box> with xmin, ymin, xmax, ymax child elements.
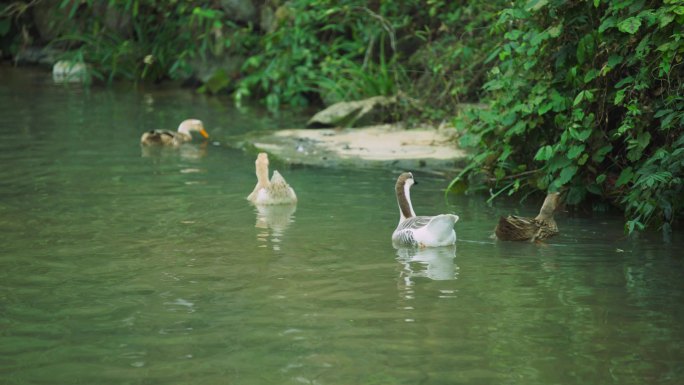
<box><xmin>397</xmin><ymin>245</ymin><xmax>458</xmax><ymax>280</ymax></box>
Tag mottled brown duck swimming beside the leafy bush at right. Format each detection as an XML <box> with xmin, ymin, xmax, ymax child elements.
<box><xmin>494</xmin><ymin>192</ymin><xmax>560</xmax><ymax>242</ymax></box>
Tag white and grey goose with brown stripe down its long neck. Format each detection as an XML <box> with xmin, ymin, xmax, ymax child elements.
<box><xmin>392</xmin><ymin>172</ymin><xmax>459</xmax><ymax>248</ymax></box>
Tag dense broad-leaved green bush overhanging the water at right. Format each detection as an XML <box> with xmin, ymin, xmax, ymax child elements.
<box><xmin>458</xmin><ymin>0</ymin><xmax>684</xmax><ymax>232</ymax></box>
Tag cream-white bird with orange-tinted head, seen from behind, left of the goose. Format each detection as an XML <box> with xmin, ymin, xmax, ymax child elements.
<box><xmin>247</xmin><ymin>152</ymin><xmax>297</xmax><ymax>205</ymax></box>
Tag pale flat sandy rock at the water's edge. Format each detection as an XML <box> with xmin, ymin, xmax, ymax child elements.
<box><xmin>238</xmin><ymin>124</ymin><xmax>467</xmax><ymax>172</ymax></box>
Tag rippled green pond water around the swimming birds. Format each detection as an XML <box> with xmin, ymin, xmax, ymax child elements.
<box><xmin>0</xmin><ymin>64</ymin><xmax>684</xmax><ymax>385</ymax></box>
